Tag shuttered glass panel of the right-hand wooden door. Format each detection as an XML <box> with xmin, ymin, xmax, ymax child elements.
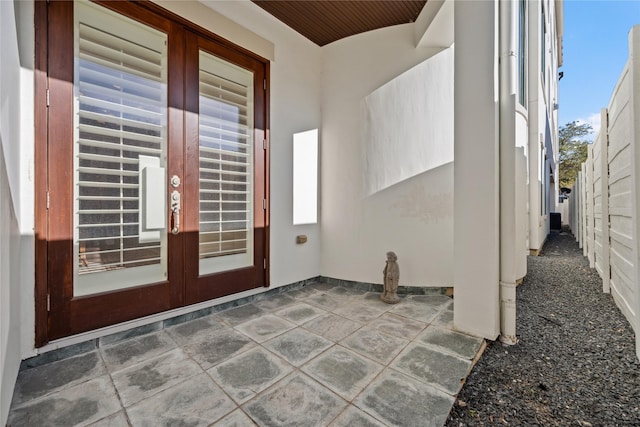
<box><xmin>199</xmin><ymin>51</ymin><xmax>253</xmax><ymax>275</ymax></box>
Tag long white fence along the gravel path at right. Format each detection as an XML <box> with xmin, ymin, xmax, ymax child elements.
<box><xmin>568</xmin><ymin>25</ymin><xmax>640</xmax><ymax>358</ymax></box>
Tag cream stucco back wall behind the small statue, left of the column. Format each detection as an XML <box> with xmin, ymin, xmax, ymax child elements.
<box><xmin>321</xmin><ymin>24</ymin><xmax>453</xmax><ymax>286</ymax></box>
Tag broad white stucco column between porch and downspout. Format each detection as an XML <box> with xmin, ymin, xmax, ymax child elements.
<box><xmin>453</xmin><ymin>1</ymin><xmax>501</xmax><ymax>340</ymax></box>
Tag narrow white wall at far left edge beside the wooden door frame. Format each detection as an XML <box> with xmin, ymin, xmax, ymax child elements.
<box><xmin>0</xmin><ymin>1</ymin><xmax>34</xmax><ymax>425</ymax></box>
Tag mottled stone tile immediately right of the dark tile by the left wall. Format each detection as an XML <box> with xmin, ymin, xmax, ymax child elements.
<box><xmin>111</xmin><ymin>349</ymin><xmax>203</xmax><ymax>407</ymax></box>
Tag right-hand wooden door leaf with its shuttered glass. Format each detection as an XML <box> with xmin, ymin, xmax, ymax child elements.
<box><xmin>185</xmin><ymin>33</ymin><xmax>267</xmax><ymax>303</ymax></box>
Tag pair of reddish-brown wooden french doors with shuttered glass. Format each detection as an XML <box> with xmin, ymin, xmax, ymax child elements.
<box><xmin>42</xmin><ymin>1</ymin><xmax>268</xmax><ymax>340</ymax></box>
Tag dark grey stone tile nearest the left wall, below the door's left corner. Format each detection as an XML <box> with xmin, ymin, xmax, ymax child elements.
<box><xmin>13</xmin><ymin>350</ymin><xmax>107</xmax><ymax>405</ymax></box>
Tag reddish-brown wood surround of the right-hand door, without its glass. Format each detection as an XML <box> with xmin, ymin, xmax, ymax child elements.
<box><xmin>184</xmin><ymin>32</ymin><xmax>268</xmax><ymax>304</ymax></box>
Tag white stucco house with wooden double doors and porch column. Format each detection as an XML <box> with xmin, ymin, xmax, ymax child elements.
<box><xmin>0</xmin><ymin>0</ymin><xmax>562</xmax><ymax>422</ymax></box>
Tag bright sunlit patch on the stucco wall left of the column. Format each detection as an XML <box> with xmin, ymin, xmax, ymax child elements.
<box><xmin>359</xmin><ymin>48</ymin><xmax>453</xmax><ymax>196</ymax></box>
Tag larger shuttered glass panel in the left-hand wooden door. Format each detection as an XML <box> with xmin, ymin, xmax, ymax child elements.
<box><xmin>74</xmin><ymin>2</ymin><xmax>167</xmax><ymax>296</ymax></box>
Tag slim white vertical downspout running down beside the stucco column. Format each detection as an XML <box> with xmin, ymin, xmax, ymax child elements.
<box><xmin>498</xmin><ymin>1</ymin><xmax>518</xmax><ymax>344</ymax></box>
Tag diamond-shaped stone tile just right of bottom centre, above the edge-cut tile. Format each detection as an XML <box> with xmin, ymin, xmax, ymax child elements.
<box><xmin>302</xmin><ymin>346</ymin><xmax>384</xmax><ymax>402</ymax></box>
